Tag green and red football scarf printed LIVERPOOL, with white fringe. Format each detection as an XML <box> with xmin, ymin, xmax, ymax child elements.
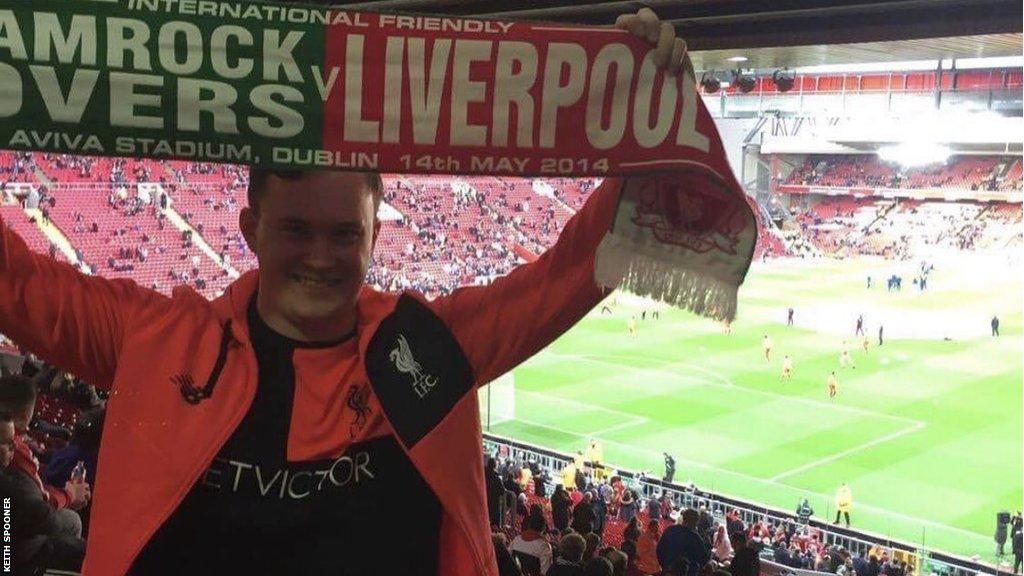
<box><xmin>0</xmin><ymin>0</ymin><xmax>757</xmax><ymax>319</ymax></box>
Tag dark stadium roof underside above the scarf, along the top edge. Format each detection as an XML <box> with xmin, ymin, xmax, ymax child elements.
<box><xmin>324</xmin><ymin>0</ymin><xmax>1024</xmax><ymax>70</ymax></box>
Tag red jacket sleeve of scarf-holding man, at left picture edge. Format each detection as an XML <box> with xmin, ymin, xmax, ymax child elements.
<box><xmin>0</xmin><ymin>213</ymin><xmax>156</xmax><ymax>388</ymax></box>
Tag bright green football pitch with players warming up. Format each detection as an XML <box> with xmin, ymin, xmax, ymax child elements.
<box><xmin>492</xmin><ymin>258</ymin><xmax>1024</xmax><ymax>560</ymax></box>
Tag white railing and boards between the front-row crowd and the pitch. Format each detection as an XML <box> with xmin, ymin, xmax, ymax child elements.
<box><xmin>483</xmin><ymin>434</ymin><xmax>1010</xmax><ymax>576</ymax></box>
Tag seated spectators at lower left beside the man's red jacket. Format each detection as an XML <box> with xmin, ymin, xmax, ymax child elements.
<box><xmin>0</xmin><ymin>355</ymin><xmax>106</xmax><ymax>574</ymax></box>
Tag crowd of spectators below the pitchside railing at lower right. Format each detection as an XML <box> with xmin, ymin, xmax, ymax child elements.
<box><xmin>484</xmin><ymin>454</ymin><xmax>912</xmax><ymax>576</ymax></box>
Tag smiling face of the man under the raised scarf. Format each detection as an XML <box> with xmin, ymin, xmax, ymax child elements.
<box><xmin>241</xmin><ymin>171</ymin><xmax>380</xmax><ymax>335</ymax></box>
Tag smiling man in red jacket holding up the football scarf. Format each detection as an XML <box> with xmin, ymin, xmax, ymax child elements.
<box><xmin>0</xmin><ymin>9</ymin><xmax>685</xmax><ymax>576</ymax></box>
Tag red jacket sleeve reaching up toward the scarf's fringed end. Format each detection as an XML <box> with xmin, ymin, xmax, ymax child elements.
<box><xmin>430</xmin><ymin>178</ymin><xmax>622</xmax><ymax>385</ymax></box>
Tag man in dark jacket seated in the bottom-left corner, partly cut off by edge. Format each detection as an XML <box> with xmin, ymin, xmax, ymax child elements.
<box><xmin>0</xmin><ymin>411</ymin><xmax>85</xmax><ymax>574</ymax></box>
